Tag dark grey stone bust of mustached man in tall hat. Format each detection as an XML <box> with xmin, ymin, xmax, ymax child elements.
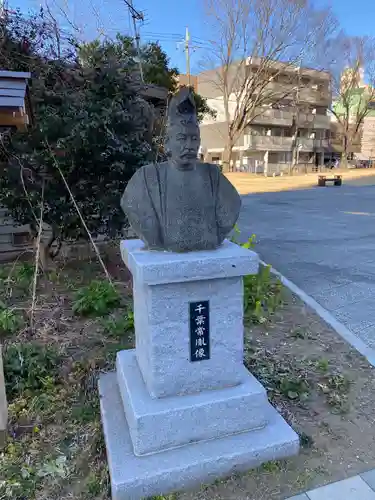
<box><xmin>121</xmin><ymin>88</ymin><xmax>241</xmax><ymax>252</ymax></box>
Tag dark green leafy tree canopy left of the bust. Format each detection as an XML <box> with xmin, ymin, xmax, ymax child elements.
<box><xmin>0</xmin><ymin>10</ymin><xmax>216</xmax><ymax>260</ymax></box>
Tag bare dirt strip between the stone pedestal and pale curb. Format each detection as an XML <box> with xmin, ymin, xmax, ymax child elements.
<box><xmin>177</xmin><ymin>293</ymin><xmax>375</xmax><ymax>500</ymax></box>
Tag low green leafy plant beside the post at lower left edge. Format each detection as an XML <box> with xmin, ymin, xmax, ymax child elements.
<box><xmin>3</xmin><ymin>344</ymin><xmax>60</xmax><ymax>401</ymax></box>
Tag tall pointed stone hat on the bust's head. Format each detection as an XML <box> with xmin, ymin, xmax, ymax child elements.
<box><xmin>167</xmin><ymin>87</ymin><xmax>198</xmax><ymax>127</ymax></box>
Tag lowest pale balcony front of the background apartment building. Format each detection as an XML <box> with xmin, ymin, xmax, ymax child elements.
<box><xmin>244</xmin><ymin>134</ymin><xmax>329</xmax><ymax>151</ymax></box>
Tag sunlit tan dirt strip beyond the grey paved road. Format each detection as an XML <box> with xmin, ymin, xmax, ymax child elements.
<box><xmin>226</xmin><ymin>169</ymin><xmax>375</xmax><ymax>195</ymax></box>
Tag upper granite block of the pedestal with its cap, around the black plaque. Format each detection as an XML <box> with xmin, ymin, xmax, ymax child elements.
<box><xmin>123</xmin><ymin>240</ymin><xmax>258</xmax><ymax>397</ymax></box>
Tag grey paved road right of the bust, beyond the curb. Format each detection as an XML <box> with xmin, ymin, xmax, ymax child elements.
<box><xmin>239</xmin><ymin>185</ymin><xmax>375</xmax><ymax>349</ymax></box>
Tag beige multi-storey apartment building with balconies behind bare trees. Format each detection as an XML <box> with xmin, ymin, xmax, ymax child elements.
<box><xmin>198</xmin><ymin>59</ymin><xmax>331</xmax><ymax>175</ymax></box>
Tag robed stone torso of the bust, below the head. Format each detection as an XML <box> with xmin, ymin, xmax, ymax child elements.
<box><xmin>121</xmin><ymin>162</ymin><xmax>241</xmax><ymax>252</ymax></box>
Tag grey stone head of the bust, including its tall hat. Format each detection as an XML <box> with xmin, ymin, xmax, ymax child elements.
<box><xmin>165</xmin><ymin>87</ymin><xmax>200</xmax><ymax>170</ymax></box>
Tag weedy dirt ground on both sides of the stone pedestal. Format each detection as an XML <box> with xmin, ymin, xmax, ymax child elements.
<box><xmin>0</xmin><ymin>251</ymin><xmax>375</xmax><ymax>500</ymax></box>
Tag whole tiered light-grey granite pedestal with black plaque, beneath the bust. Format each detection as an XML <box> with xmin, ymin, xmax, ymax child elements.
<box><xmin>99</xmin><ymin>240</ymin><xmax>299</xmax><ymax>500</ymax></box>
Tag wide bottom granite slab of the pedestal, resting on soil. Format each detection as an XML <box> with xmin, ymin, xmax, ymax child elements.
<box><xmin>99</xmin><ymin>373</ymin><xmax>299</xmax><ymax>500</ymax></box>
